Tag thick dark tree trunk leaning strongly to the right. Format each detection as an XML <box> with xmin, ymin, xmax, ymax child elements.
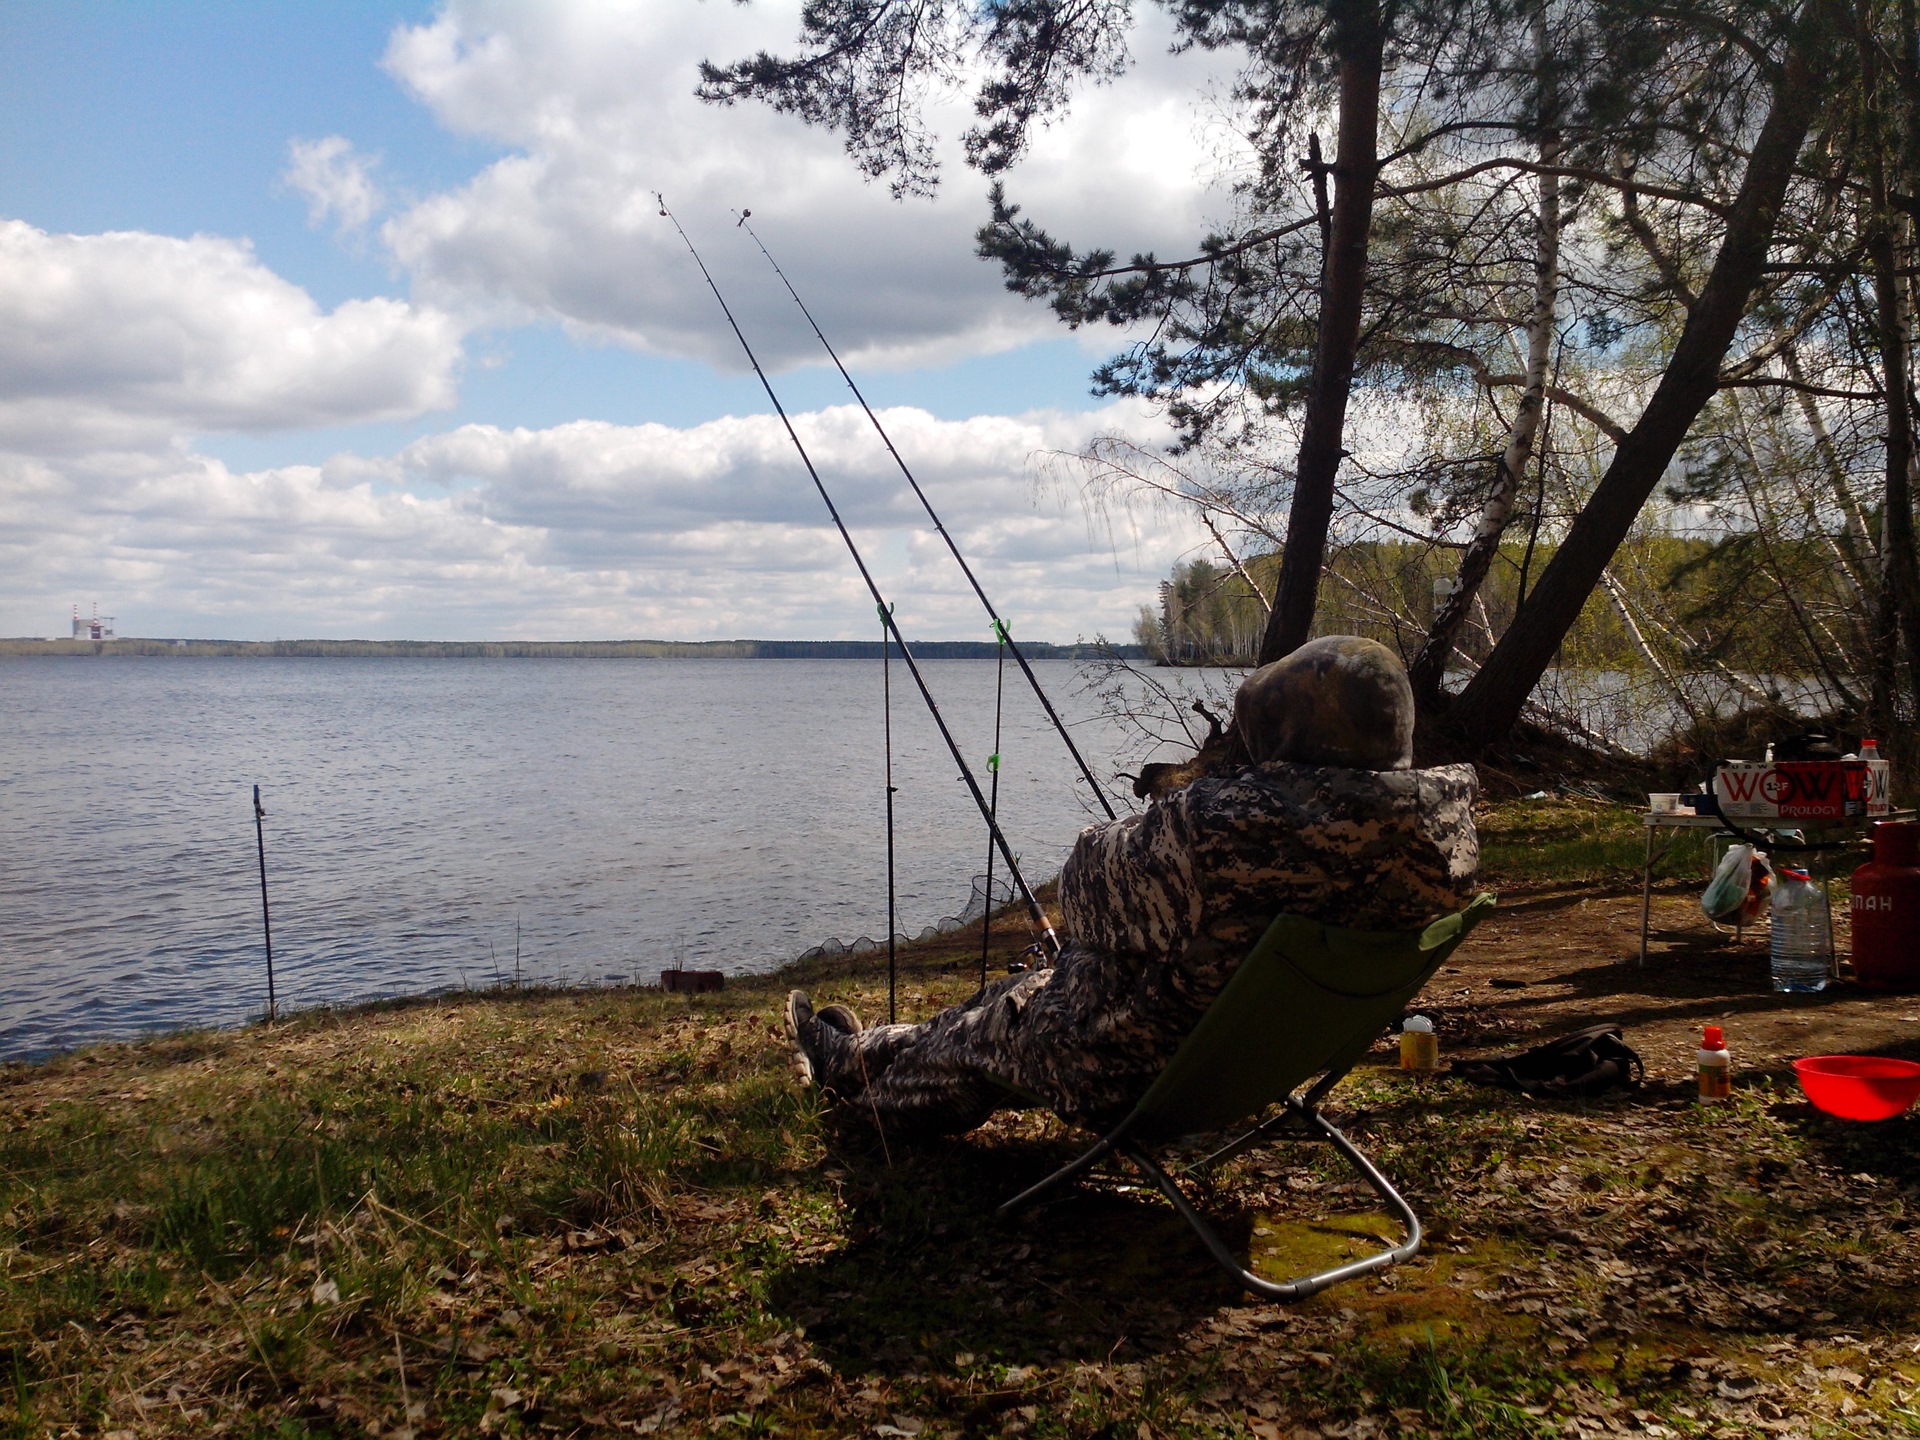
<box><xmin>1448</xmin><ymin>19</ymin><xmax>1828</xmax><ymax>751</ymax></box>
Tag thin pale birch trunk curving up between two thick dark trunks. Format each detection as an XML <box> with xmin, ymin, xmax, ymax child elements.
<box><xmin>1407</xmin><ymin>8</ymin><xmax>1559</xmax><ymax>710</ymax></box>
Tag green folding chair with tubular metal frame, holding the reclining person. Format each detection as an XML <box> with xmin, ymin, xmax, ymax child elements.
<box><xmin>996</xmin><ymin>895</ymin><xmax>1494</xmax><ymax>1300</ymax></box>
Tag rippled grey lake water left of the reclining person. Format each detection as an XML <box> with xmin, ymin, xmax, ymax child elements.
<box><xmin>0</xmin><ymin>659</ymin><xmax>1117</xmax><ymax>1058</ymax></box>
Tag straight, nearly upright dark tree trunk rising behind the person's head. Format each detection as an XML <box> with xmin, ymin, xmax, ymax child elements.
<box><xmin>1260</xmin><ymin>0</ymin><xmax>1386</xmax><ymax>664</ymax></box>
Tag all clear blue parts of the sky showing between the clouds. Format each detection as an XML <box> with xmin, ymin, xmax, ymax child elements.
<box><xmin>0</xmin><ymin>0</ymin><xmax>1096</xmax><ymax>439</ymax></box>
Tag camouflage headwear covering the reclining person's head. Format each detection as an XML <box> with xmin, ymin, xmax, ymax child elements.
<box><xmin>1233</xmin><ymin>636</ymin><xmax>1413</xmax><ymax>770</ymax></box>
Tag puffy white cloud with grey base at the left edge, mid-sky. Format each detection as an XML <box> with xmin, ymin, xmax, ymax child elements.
<box><xmin>0</xmin><ymin>221</ymin><xmax>461</xmax><ymax>453</ymax></box>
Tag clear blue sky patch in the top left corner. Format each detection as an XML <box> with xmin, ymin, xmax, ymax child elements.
<box><xmin>0</xmin><ymin>0</ymin><xmax>464</xmax><ymax>305</ymax></box>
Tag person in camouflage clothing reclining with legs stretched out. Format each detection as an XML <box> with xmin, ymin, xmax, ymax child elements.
<box><xmin>787</xmin><ymin>636</ymin><xmax>1478</xmax><ymax>1139</ymax></box>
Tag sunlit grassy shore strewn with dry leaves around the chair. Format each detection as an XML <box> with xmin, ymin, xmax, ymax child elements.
<box><xmin>0</xmin><ymin>803</ymin><xmax>1920</xmax><ymax>1440</ymax></box>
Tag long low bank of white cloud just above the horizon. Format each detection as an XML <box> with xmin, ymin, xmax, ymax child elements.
<box><xmin>0</xmin><ymin>397</ymin><xmax>1196</xmax><ymax>639</ymax></box>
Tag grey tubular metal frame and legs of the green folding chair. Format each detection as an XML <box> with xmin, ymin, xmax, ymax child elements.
<box><xmin>995</xmin><ymin>897</ymin><xmax>1492</xmax><ymax>1302</ymax></box>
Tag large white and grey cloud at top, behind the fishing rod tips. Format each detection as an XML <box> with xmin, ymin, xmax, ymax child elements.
<box><xmin>370</xmin><ymin>0</ymin><xmax>1212</xmax><ymax>369</ymax></box>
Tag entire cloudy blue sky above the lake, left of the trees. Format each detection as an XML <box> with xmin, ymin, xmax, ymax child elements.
<box><xmin>0</xmin><ymin>0</ymin><xmax>1208</xmax><ymax>637</ymax></box>
